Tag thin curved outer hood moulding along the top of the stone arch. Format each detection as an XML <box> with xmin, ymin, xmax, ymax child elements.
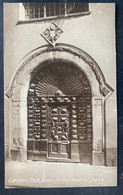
<box><xmin>11</xmin><ymin>44</ymin><xmax>113</xmax><ymax>99</ymax></box>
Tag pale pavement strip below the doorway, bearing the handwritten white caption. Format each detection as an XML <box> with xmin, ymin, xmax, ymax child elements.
<box><xmin>5</xmin><ymin>161</ymin><xmax>117</xmax><ymax>188</ymax></box>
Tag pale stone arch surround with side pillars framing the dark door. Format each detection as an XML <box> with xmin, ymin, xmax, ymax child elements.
<box><xmin>6</xmin><ymin>44</ymin><xmax>113</xmax><ymax>165</ymax></box>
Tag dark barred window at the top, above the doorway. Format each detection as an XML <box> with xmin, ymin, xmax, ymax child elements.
<box><xmin>20</xmin><ymin>3</ymin><xmax>90</xmax><ymax>21</ymax></box>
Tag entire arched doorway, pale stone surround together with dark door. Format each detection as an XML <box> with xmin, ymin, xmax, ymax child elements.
<box><xmin>5</xmin><ymin>44</ymin><xmax>113</xmax><ymax>165</ymax></box>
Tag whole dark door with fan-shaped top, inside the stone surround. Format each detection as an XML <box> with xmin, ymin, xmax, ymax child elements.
<box><xmin>27</xmin><ymin>61</ymin><xmax>92</xmax><ymax>163</ymax></box>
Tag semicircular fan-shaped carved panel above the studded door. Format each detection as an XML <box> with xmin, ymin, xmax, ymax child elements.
<box><xmin>30</xmin><ymin>59</ymin><xmax>91</xmax><ymax>95</ymax></box>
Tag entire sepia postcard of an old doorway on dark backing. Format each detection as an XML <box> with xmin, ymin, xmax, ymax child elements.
<box><xmin>4</xmin><ymin>2</ymin><xmax>117</xmax><ymax>188</ymax></box>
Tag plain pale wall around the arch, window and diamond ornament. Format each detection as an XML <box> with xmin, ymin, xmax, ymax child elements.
<box><xmin>4</xmin><ymin>3</ymin><xmax>117</xmax><ymax>165</ymax></box>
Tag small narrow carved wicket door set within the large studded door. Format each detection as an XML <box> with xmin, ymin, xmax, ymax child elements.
<box><xmin>47</xmin><ymin>102</ymin><xmax>71</xmax><ymax>158</ymax></box>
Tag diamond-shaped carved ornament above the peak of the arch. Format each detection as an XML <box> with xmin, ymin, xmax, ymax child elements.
<box><xmin>41</xmin><ymin>21</ymin><xmax>63</xmax><ymax>46</ymax></box>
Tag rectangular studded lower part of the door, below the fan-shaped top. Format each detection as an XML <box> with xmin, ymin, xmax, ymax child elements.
<box><xmin>27</xmin><ymin>96</ymin><xmax>92</xmax><ymax>162</ymax></box>
